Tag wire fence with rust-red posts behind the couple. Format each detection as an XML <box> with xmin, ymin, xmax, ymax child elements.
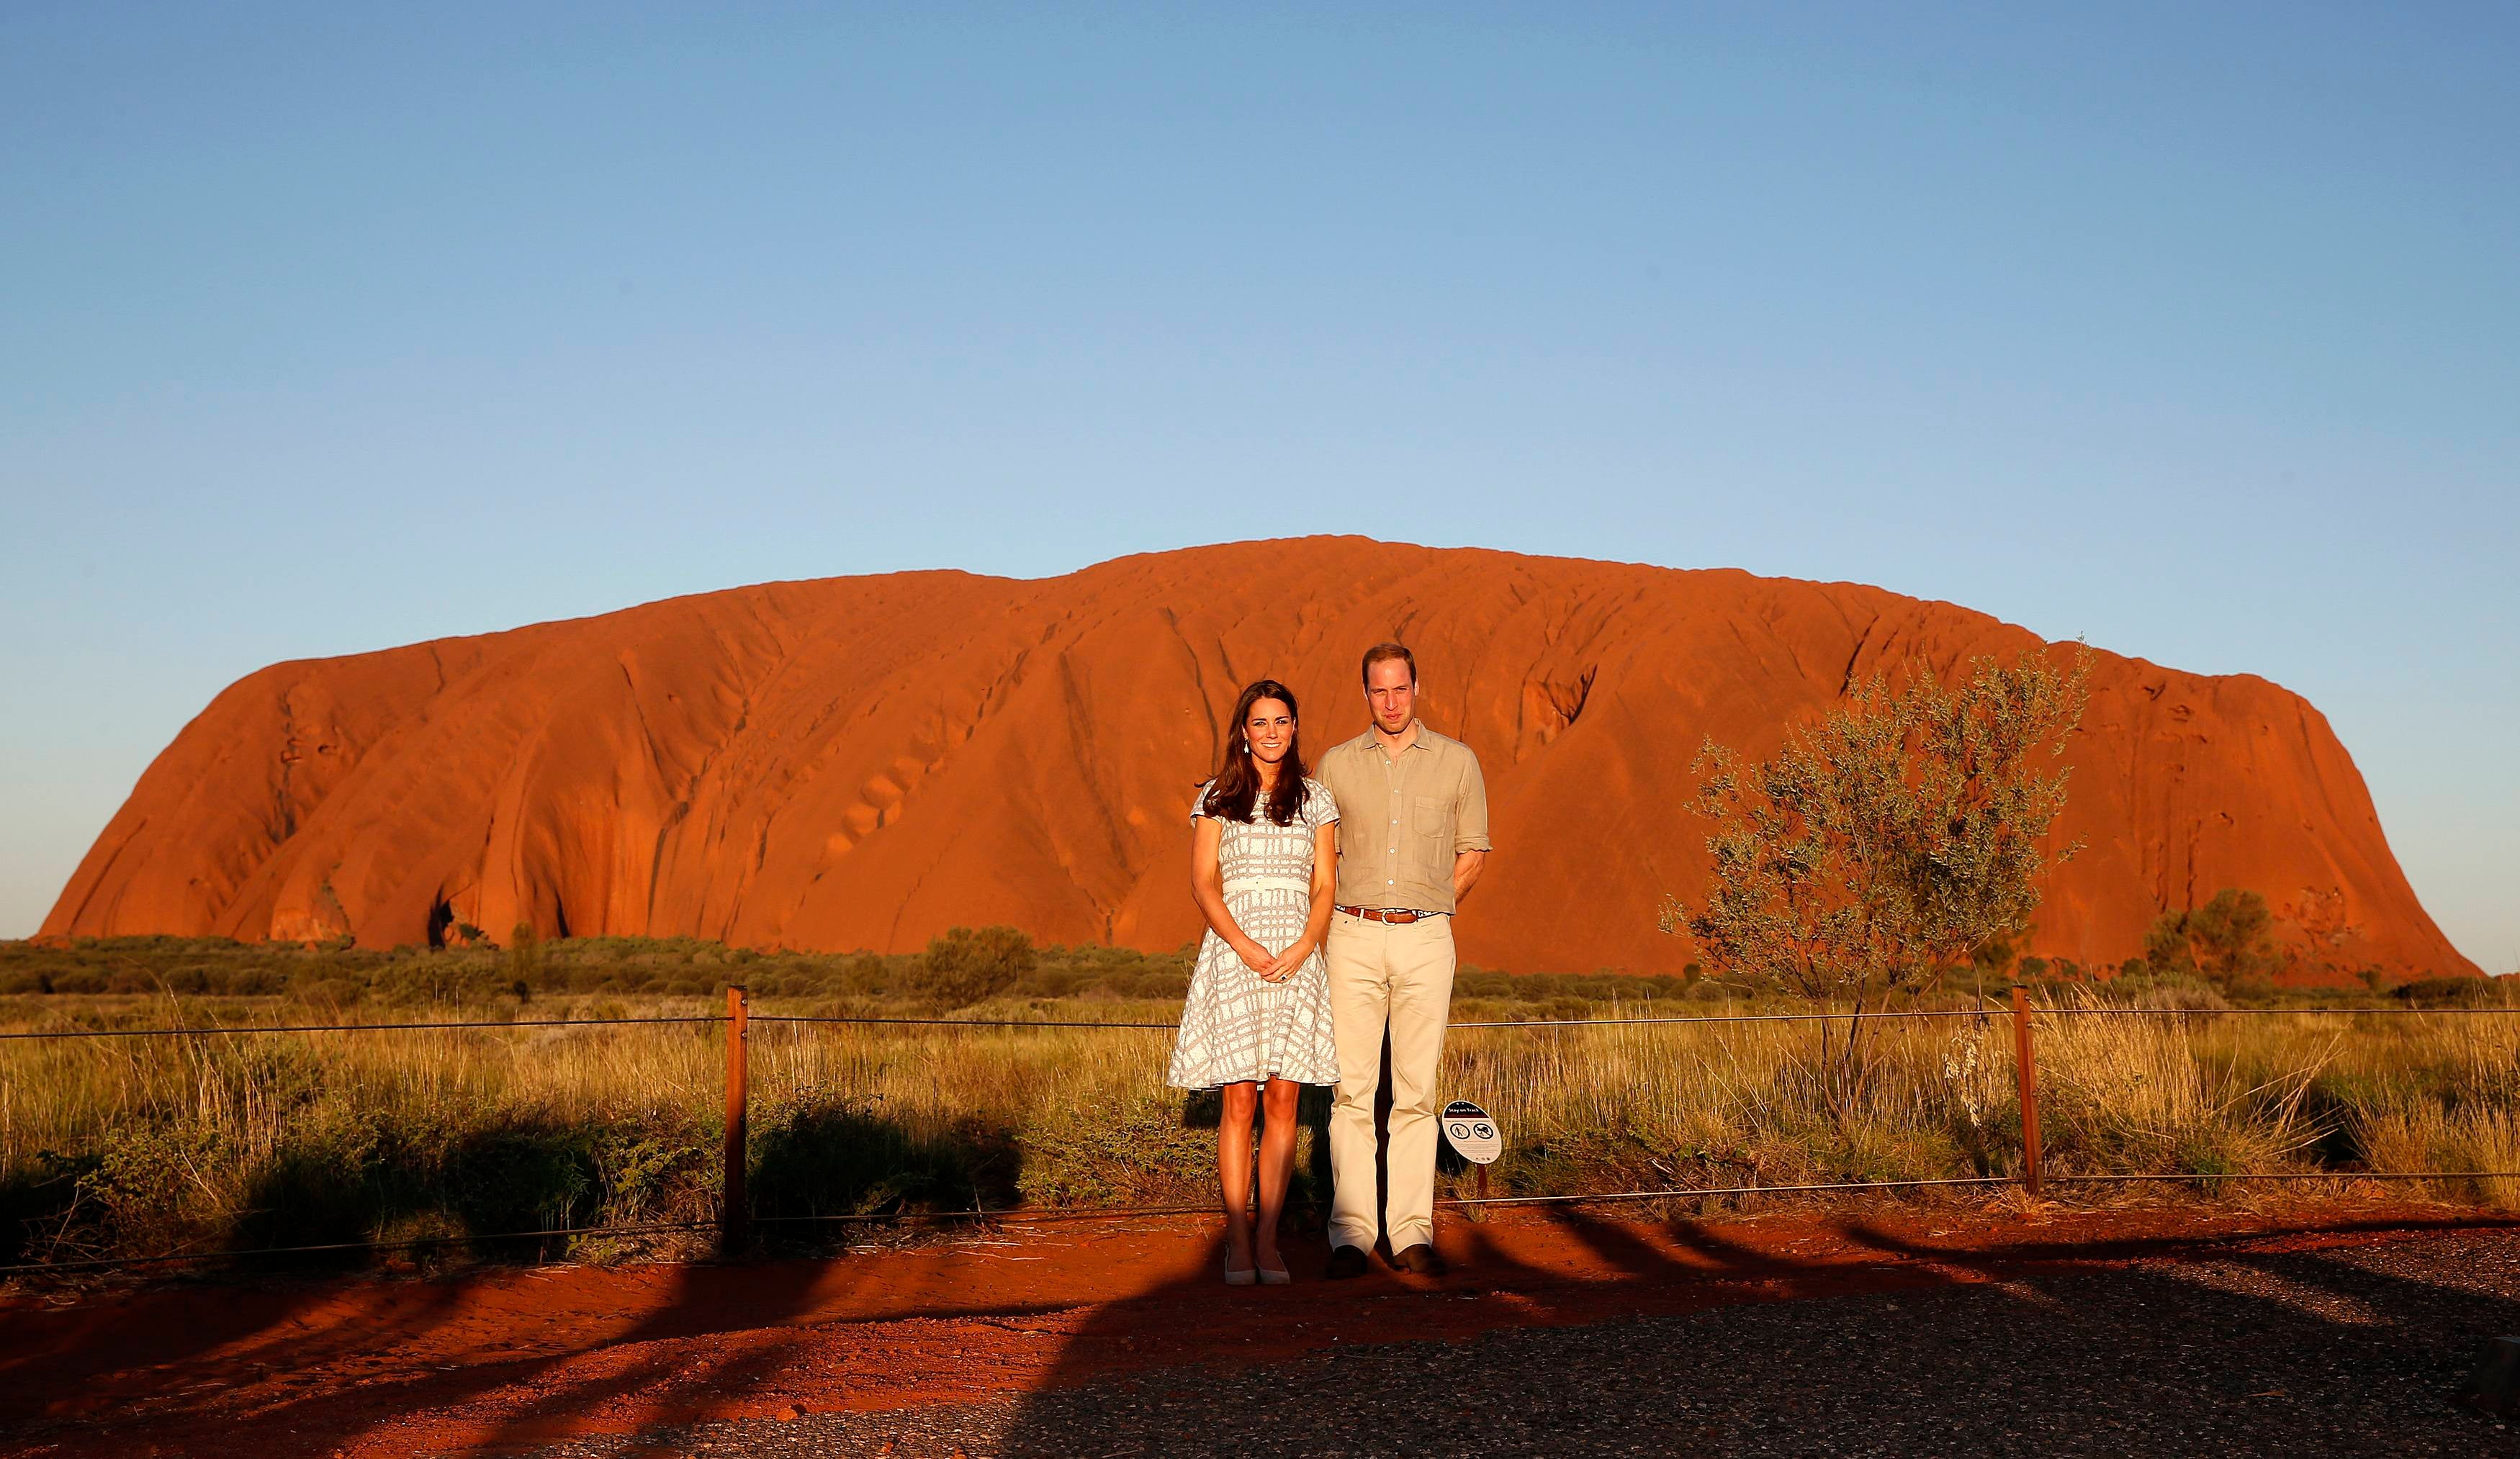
<box><xmin>0</xmin><ymin>985</ymin><xmax>2520</xmax><ymax>1278</ymax></box>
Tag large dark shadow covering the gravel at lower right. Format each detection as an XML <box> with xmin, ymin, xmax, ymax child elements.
<box><xmin>978</xmin><ymin>1214</ymin><xmax>2520</xmax><ymax>1454</ymax></box>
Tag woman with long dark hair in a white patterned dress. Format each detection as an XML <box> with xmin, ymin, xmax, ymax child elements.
<box><xmin>1167</xmin><ymin>678</ymin><xmax>1338</xmax><ymax>1288</ymax></box>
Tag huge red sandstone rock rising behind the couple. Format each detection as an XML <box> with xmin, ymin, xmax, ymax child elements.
<box><xmin>43</xmin><ymin>539</ymin><xmax>2472</xmax><ymax>975</ymax></box>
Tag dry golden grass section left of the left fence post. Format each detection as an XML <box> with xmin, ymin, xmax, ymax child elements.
<box><xmin>0</xmin><ymin>1008</ymin><xmax>724</xmax><ymax>1260</ymax></box>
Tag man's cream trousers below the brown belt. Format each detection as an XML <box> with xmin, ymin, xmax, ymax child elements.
<box><xmin>1326</xmin><ymin>912</ymin><xmax>1452</xmax><ymax>1252</ymax></box>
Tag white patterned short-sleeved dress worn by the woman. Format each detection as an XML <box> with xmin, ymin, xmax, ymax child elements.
<box><xmin>1164</xmin><ymin>779</ymin><xmax>1338</xmax><ymax>1088</ymax></box>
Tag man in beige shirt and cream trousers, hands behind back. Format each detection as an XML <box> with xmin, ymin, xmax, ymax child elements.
<box><xmin>1318</xmin><ymin>643</ymin><xmax>1487</xmax><ymax>1278</ymax></box>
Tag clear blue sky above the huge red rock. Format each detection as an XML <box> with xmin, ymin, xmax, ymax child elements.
<box><xmin>0</xmin><ymin>5</ymin><xmax>2520</xmax><ymax>970</ymax></box>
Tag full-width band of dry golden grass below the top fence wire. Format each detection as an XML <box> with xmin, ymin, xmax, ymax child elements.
<box><xmin>0</xmin><ymin>998</ymin><xmax>2520</xmax><ymax>1262</ymax></box>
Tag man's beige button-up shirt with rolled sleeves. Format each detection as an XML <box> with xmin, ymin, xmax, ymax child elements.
<box><xmin>1315</xmin><ymin>721</ymin><xmax>1490</xmax><ymax>912</ymax></box>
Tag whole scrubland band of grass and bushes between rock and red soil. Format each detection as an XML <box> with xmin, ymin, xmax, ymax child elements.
<box><xmin>0</xmin><ymin>940</ymin><xmax>2520</xmax><ymax>1265</ymax></box>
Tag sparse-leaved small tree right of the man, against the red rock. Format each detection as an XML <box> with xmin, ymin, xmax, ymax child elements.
<box><xmin>1663</xmin><ymin>650</ymin><xmax>2092</xmax><ymax>1108</ymax></box>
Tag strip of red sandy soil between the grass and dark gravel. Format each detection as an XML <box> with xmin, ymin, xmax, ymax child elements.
<box><xmin>0</xmin><ymin>1204</ymin><xmax>2515</xmax><ymax>1459</ymax></box>
